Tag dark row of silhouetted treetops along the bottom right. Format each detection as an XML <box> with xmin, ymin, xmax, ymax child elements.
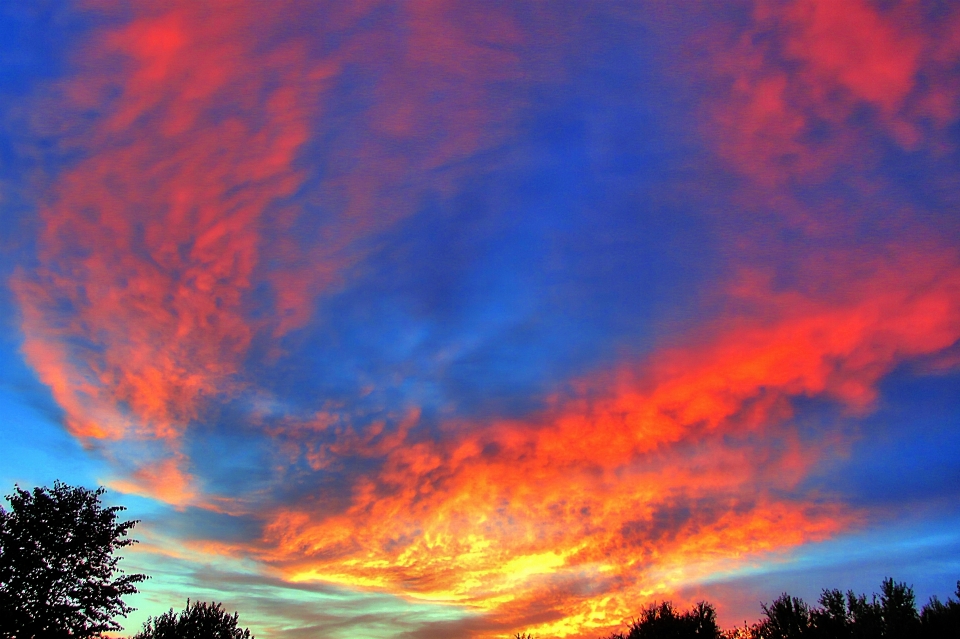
<box><xmin>592</xmin><ymin>579</ymin><xmax>960</xmax><ymax>639</ymax></box>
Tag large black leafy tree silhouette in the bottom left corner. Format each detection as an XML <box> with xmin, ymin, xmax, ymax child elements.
<box><xmin>0</xmin><ymin>481</ymin><xmax>146</xmax><ymax>639</ymax></box>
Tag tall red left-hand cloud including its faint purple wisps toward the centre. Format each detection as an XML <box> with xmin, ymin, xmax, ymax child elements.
<box><xmin>14</xmin><ymin>2</ymin><xmax>516</xmax><ymax>504</ymax></box>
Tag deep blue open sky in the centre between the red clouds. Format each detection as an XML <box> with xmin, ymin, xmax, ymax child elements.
<box><xmin>260</xmin><ymin>52</ymin><xmax>719</xmax><ymax>424</ymax></box>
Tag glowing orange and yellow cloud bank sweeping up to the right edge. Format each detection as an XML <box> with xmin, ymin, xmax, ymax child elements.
<box><xmin>236</xmin><ymin>239</ymin><xmax>960</xmax><ymax>636</ymax></box>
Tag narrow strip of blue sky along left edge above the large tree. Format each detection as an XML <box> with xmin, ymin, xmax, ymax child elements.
<box><xmin>0</xmin><ymin>0</ymin><xmax>105</xmax><ymax>494</ymax></box>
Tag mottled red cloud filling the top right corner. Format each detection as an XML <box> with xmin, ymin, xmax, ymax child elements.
<box><xmin>695</xmin><ymin>0</ymin><xmax>960</xmax><ymax>186</ymax></box>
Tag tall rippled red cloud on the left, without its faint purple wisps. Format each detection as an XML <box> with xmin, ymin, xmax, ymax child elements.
<box><xmin>17</xmin><ymin>3</ymin><xmax>313</xmax><ymax>448</ymax></box>
